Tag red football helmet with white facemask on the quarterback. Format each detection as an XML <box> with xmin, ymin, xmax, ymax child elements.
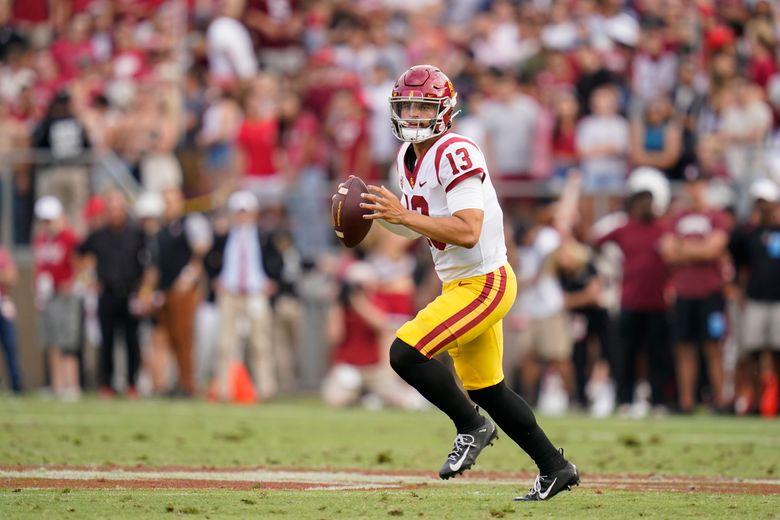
<box><xmin>390</xmin><ymin>65</ymin><xmax>458</xmax><ymax>143</ymax></box>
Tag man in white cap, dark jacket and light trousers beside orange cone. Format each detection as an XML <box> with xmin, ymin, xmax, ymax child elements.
<box><xmin>208</xmin><ymin>190</ymin><xmax>283</xmax><ymax>401</ymax></box>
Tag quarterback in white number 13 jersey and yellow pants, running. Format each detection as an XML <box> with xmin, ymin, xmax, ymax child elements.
<box><xmin>362</xmin><ymin>65</ymin><xmax>579</xmax><ymax>500</ymax></box>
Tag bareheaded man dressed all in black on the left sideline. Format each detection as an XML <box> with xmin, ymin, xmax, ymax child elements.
<box><xmin>79</xmin><ymin>192</ymin><xmax>145</xmax><ymax>397</ymax></box>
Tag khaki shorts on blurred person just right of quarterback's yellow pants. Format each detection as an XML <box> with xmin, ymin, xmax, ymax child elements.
<box><xmin>518</xmin><ymin>312</ymin><xmax>572</xmax><ymax>361</ymax></box>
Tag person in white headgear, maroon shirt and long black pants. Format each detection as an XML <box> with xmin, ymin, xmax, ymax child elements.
<box><xmin>596</xmin><ymin>168</ymin><xmax>673</xmax><ymax>410</ymax></box>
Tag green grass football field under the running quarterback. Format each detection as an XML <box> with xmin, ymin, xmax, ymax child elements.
<box><xmin>0</xmin><ymin>397</ymin><xmax>780</xmax><ymax>520</ymax></box>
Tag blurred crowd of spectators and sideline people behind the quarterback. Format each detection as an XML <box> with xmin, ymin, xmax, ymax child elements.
<box><xmin>0</xmin><ymin>0</ymin><xmax>780</xmax><ymax>413</ymax></box>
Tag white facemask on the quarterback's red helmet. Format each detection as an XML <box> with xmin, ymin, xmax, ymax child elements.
<box><xmin>390</xmin><ymin>96</ymin><xmax>457</xmax><ymax>143</ymax></box>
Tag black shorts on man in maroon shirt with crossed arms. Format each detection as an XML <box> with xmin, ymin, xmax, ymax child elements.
<box><xmin>672</xmin><ymin>293</ymin><xmax>727</xmax><ymax>344</ymax></box>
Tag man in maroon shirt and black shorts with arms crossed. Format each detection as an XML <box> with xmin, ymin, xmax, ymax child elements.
<box><xmin>661</xmin><ymin>167</ymin><xmax>729</xmax><ymax>413</ymax></box>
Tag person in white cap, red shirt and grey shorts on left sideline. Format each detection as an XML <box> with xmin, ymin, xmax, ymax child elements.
<box><xmin>32</xmin><ymin>196</ymin><xmax>81</xmax><ymax>400</ymax></box>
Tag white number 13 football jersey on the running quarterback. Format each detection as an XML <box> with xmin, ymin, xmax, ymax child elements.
<box><xmin>396</xmin><ymin>133</ymin><xmax>507</xmax><ymax>282</ymax></box>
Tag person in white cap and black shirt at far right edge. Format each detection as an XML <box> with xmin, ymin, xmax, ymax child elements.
<box><xmin>729</xmin><ymin>178</ymin><xmax>780</xmax><ymax>415</ymax></box>
